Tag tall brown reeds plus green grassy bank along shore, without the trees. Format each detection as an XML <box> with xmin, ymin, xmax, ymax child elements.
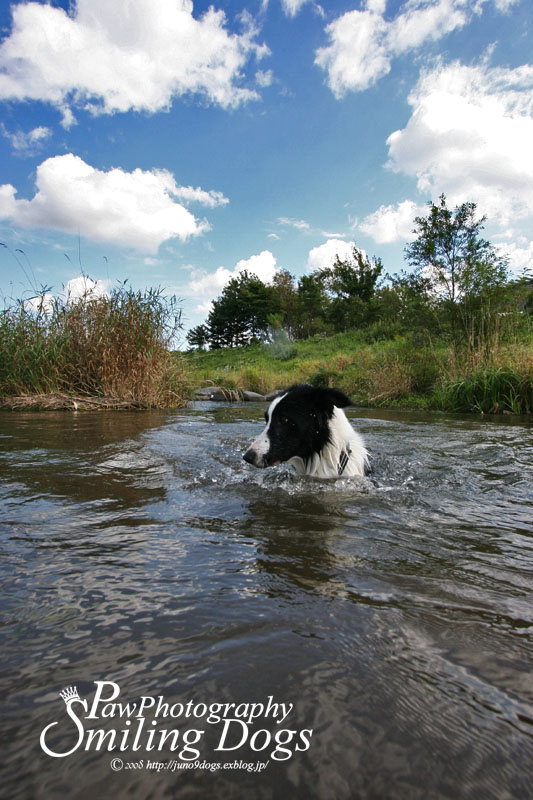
<box><xmin>0</xmin><ymin>286</ymin><xmax>533</xmax><ymax>414</ymax></box>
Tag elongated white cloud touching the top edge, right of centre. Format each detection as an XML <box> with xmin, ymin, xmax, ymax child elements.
<box><xmin>315</xmin><ymin>0</ymin><xmax>515</xmax><ymax>98</ymax></box>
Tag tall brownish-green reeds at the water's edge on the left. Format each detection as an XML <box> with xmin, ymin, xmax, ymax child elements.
<box><xmin>0</xmin><ymin>285</ymin><xmax>189</xmax><ymax>408</ymax></box>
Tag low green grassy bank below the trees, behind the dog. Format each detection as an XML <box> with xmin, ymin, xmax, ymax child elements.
<box><xmin>186</xmin><ymin>331</ymin><xmax>533</xmax><ymax>414</ymax></box>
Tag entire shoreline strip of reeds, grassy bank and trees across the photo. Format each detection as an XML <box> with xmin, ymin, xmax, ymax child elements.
<box><xmin>0</xmin><ymin>196</ymin><xmax>533</xmax><ymax>414</ymax></box>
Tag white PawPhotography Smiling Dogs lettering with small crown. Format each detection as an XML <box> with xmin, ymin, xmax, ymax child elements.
<box><xmin>40</xmin><ymin>681</ymin><xmax>313</xmax><ymax>768</ymax></box>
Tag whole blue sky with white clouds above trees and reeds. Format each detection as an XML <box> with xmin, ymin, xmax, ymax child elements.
<box><xmin>0</xmin><ymin>0</ymin><xmax>533</xmax><ymax>334</ymax></box>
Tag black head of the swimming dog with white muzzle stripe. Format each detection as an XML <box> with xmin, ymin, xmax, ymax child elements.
<box><xmin>243</xmin><ymin>384</ymin><xmax>351</xmax><ymax>467</ymax></box>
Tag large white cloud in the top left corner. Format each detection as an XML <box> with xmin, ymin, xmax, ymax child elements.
<box><xmin>0</xmin><ymin>0</ymin><xmax>269</xmax><ymax>122</ymax></box>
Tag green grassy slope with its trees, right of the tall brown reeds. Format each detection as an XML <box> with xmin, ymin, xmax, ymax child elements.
<box><xmin>188</xmin><ymin>196</ymin><xmax>533</xmax><ymax>414</ymax></box>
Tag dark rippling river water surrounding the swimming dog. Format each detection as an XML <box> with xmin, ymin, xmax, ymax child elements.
<box><xmin>0</xmin><ymin>403</ymin><xmax>533</xmax><ymax>800</ymax></box>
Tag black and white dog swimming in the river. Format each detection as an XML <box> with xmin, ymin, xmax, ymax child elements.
<box><xmin>243</xmin><ymin>383</ymin><xmax>368</xmax><ymax>478</ymax></box>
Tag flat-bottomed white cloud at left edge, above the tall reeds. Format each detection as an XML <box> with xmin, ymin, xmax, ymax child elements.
<box><xmin>0</xmin><ymin>153</ymin><xmax>222</xmax><ymax>255</ymax></box>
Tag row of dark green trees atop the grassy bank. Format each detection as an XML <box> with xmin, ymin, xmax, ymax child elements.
<box><xmin>187</xmin><ymin>195</ymin><xmax>533</xmax><ymax>349</ymax></box>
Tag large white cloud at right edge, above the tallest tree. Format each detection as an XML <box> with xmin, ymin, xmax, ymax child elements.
<box><xmin>387</xmin><ymin>62</ymin><xmax>533</xmax><ymax>226</ymax></box>
